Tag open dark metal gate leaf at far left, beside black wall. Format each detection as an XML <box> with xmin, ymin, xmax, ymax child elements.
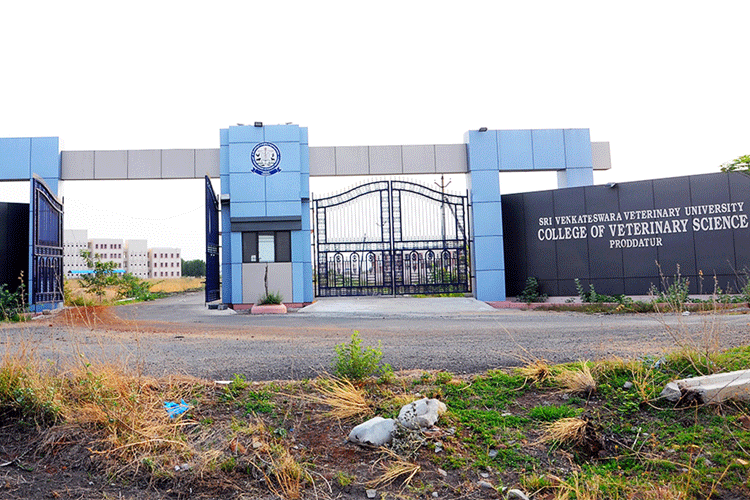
<box><xmin>31</xmin><ymin>175</ymin><xmax>63</xmax><ymax>304</ymax></box>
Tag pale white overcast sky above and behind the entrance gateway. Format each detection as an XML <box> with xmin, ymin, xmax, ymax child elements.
<box><xmin>0</xmin><ymin>0</ymin><xmax>750</xmax><ymax>258</ymax></box>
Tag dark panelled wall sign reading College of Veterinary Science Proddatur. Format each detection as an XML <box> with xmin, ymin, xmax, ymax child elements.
<box><xmin>502</xmin><ymin>173</ymin><xmax>750</xmax><ymax>296</ymax></box>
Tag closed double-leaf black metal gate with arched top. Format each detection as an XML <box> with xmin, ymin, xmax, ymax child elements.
<box><xmin>314</xmin><ymin>180</ymin><xmax>471</xmax><ymax>297</ymax></box>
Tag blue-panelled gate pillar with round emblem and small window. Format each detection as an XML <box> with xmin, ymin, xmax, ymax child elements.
<box><xmin>220</xmin><ymin>123</ymin><xmax>313</xmax><ymax>309</ymax></box>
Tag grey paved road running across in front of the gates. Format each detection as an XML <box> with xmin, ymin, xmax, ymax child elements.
<box><xmin>0</xmin><ymin>293</ymin><xmax>750</xmax><ymax>380</ymax></box>
